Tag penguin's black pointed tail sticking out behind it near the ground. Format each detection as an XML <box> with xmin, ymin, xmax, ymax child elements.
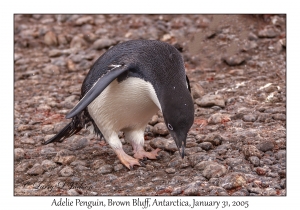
<box><xmin>43</xmin><ymin>120</ymin><xmax>83</xmax><ymax>144</ymax></box>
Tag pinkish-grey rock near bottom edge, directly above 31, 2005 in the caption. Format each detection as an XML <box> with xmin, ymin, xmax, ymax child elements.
<box><xmin>219</xmin><ymin>172</ymin><xmax>247</xmax><ymax>190</ymax></box>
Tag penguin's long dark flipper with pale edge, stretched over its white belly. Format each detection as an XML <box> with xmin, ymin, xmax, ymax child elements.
<box><xmin>66</xmin><ymin>65</ymin><xmax>130</xmax><ymax>119</ymax></box>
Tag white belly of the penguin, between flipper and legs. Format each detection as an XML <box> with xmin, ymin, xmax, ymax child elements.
<box><xmin>88</xmin><ymin>77</ymin><xmax>161</xmax><ymax>137</ymax></box>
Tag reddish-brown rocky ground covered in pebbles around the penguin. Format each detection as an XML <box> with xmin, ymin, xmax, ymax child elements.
<box><xmin>14</xmin><ymin>15</ymin><xmax>286</xmax><ymax>196</ymax></box>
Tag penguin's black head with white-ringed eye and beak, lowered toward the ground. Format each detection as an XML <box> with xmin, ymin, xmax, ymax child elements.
<box><xmin>162</xmin><ymin>83</ymin><xmax>194</xmax><ymax>158</ymax></box>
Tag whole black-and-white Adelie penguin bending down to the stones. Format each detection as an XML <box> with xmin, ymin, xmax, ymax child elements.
<box><xmin>44</xmin><ymin>40</ymin><xmax>194</xmax><ymax>169</ymax></box>
